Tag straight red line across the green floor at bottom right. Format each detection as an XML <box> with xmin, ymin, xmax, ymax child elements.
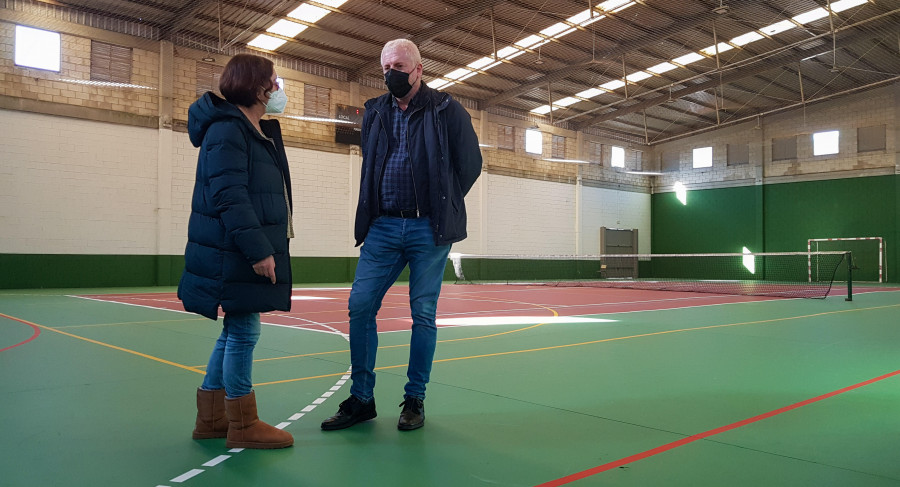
<box><xmin>535</xmin><ymin>370</ymin><xmax>900</xmax><ymax>487</ymax></box>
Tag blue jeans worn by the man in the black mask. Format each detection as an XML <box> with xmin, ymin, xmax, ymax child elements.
<box><xmin>349</xmin><ymin>216</ymin><xmax>450</xmax><ymax>402</ymax></box>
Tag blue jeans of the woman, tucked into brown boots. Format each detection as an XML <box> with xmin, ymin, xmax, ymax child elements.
<box><xmin>201</xmin><ymin>313</ymin><xmax>260</xmax><ymax>399</ymax></box>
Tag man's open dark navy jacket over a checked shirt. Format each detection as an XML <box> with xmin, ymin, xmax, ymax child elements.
<box><xmin>355</xmin><ymin>83</ymin><xmax>482</xmax><ymax>246</ymax></box>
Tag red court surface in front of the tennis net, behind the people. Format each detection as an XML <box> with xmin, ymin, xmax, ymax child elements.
<box><xmin>74</xmin><ymin>284</ymin><xmax>883</xmax><ymax>334</ymax></box>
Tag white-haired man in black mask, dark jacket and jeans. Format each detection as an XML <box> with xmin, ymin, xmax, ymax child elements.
<box><xmin>322</xmin><ymin>39</ymin><xmax>481</xmax><ymax>430</ymax></box>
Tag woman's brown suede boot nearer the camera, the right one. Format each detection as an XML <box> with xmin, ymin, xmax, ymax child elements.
<box><xmin>225</xmin><ymin>391</ymin><xmax>294</xmax><ymax>448</ymax></box>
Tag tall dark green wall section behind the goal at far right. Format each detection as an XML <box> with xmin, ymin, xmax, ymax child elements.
<box><xmin>650</xmin><ymin>175</ymin><xmax>900</xmax><ymax>282</ymax></box>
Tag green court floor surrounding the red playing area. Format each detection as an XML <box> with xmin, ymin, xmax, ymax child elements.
<box><xmin>0</xmin><ymin>288</ymin><xmax>900</xmax><ymax>487</ymax></box>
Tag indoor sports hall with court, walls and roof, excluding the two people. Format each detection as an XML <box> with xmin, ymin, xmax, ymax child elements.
<box><xmin>0</xmin><ymin>0</ymin><xmax>900</xmax><ymax>487</ymax></box>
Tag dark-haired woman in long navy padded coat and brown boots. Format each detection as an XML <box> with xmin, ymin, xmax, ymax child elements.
<box><xmin>178</xmin><ymin>54</ymin><xmax>294</xmax><ymax>448</ymax></box>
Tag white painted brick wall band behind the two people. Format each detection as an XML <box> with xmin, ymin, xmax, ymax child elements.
<box><xmin>0</xmin><ymin>110</ymin><xmax>650</xmax><ymax>257</ymax></box>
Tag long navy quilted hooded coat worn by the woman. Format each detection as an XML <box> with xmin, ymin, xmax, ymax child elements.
<box><xmin>178</xmin><ymin>93</ymin><xmax>293</xmax><ymax>320</ymax></box>
